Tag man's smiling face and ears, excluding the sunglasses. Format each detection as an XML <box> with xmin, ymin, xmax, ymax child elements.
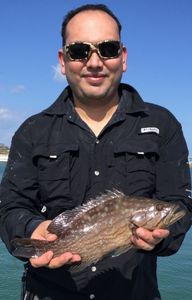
<box><xmin>59</xmin><ymin>11</ymin><xmax>127</xmax><ymax>105</ymax></box>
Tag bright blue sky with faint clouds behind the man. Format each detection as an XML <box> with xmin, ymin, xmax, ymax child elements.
<box><xmin>0</xmin><ymin>0</ymin><xmax>192</xmax><ymax>157</ymax></box>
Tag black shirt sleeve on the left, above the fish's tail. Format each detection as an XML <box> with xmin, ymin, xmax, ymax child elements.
<box><xmin>0</xmin><ymin>120</ymin><xmax>44</xmax><ymax>252</ymax></box>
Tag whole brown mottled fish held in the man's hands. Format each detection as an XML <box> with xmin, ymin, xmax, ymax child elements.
<box><xmin>12</xmin><ymin>189</ymin><xmax>186</xmax><ymax>270</ymax></box>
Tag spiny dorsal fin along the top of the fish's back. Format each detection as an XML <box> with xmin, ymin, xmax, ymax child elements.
<box><xmin>47</xmin><ymin>189</ymin><xmax>124</xmax><ymax>237</ymax></box>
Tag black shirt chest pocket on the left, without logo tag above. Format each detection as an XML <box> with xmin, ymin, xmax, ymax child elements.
<box><xmin>33</xmin><ymin>144</ymin><xmax>79</xmax><ymax>213</ymax></box>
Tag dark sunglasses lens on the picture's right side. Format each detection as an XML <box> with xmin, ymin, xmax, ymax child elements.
<box><xmin>98</xmin><ymin>41</ymin><xmax>120</xmax><ymax>57</ymax></box>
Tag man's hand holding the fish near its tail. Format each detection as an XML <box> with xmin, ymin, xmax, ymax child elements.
<box><xmin>30</xmin><ymin>220</ymin><xmax>81</xmax><ymax>269</ymax></box>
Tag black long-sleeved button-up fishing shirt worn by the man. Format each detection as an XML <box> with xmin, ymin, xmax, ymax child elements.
<box><xmin>0</xmin><ymin>84</ymin><xmax>192</xmax><ymax>300</ymax></box>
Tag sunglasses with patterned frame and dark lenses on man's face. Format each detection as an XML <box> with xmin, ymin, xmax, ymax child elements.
<box><xmin>64</xmin><ymin>40</ymin><xmax>122</xmax><ymax>60</ymax></box>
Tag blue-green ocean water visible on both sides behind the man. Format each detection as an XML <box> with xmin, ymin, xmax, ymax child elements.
<box><xmin>0</xmin><ymin>162</ymin><xmax>192</xmax><ymax>300</ymax></box>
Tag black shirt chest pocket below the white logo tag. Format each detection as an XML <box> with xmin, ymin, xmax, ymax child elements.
<box><xmin>114</xmin><ymin>140</ymin><xmax>159</xmax><ymax>197</ymax></box>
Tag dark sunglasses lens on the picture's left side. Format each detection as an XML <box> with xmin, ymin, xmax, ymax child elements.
<box><xmin>68</xmin><ymin>43</ymin><xmax>90</xmax><ymax>59</ymax></box>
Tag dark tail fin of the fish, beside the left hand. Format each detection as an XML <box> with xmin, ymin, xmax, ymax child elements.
<box><xmin>11</xmin><ymin>238</ymin><xmax>49</xmax><ymax>258</ymax></box>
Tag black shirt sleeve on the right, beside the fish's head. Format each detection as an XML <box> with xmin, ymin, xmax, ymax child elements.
<box><xmin>152</xmin><ymin>117</ymin><xmax>192</xmax><ymax>256</ymax></box>
